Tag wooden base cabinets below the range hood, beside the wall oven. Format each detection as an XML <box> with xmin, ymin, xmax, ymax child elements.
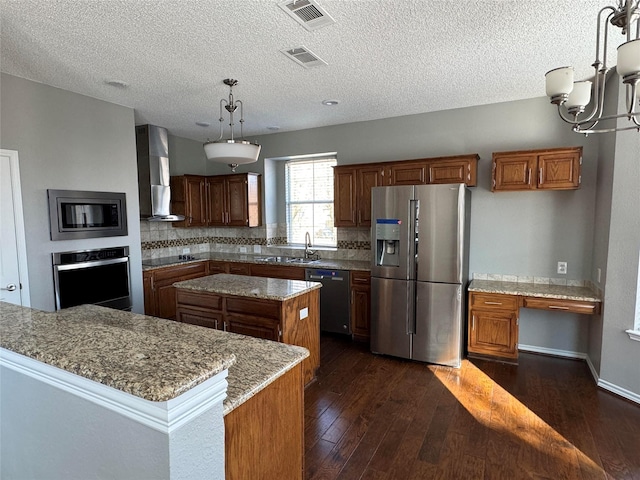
<box><xmin>143</xmin><ymin>262</ymin><xmax>209</xmax><ymax>320</ymax></box>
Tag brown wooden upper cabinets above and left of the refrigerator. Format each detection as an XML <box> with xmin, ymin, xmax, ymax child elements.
<box><xmin>333</xmin><ymin>154</ymin><xmax>479</xmax><ymax>227</ymax></box>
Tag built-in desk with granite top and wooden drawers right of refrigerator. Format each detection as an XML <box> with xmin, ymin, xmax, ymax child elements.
<box><xmin>467</xmin><ymin>280</ymin><xmax>602</xmax><ymax>362</ymax></box>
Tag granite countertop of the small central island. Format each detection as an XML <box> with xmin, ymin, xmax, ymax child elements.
<box><xmin>173</xmin><ymin>273</ymin><xmax>322</xmax><ymax>301</ymax></box>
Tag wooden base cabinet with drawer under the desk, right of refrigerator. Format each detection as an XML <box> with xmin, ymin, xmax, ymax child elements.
<box><xmin>468</xmin><ymin>292</ymin><xmax>520</xmax><ymax>361</ymax></box>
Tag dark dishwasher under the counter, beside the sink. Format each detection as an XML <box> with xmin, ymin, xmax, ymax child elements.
<box><xmin>305</xmin><ymin>268</ymin><xmax>351</xmax><ymax>335</ymax></box>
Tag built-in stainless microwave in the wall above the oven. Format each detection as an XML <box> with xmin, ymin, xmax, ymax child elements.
<box><xmin>47</xmin><ymin>189</ymin><xmax>128</xmax><ymax>240</ymax></box>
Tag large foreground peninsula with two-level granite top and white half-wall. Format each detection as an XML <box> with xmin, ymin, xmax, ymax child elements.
<box><xmin>0</xmin><ymin>303</ymin><xmax>308</xmax><ymax>479</ymax></box>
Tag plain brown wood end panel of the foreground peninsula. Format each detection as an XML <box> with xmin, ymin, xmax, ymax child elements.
<box><xmin>224</xmin><ymin>364</ymin><xmax>304</xmax><ymax>480</ymax></box>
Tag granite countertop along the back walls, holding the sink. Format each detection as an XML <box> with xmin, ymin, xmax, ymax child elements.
<box><xmin>142</xmin><ymin>252</ymin><xmax>371</xmax><ymax>272</ymax></box>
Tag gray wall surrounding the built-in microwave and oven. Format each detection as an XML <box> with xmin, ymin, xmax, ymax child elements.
<box><xmin>0</xmin><ymin>74</ymin><xmax>143</xmax><ymax>312</ymax></box>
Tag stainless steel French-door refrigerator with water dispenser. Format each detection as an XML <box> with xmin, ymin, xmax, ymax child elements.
<box><xmin>371</xmin><ymin>184</ymin><xmax>470</xmax><ymax>367</ymax></box>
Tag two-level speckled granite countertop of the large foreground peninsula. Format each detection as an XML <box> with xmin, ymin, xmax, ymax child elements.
<box><xmin>0</xmin><ymin>302</ymin><xmax>309</xmax><ymax>415</ymax></box>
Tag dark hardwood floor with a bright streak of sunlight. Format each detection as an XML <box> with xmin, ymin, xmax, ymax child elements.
<box><xmin>305</xmin><ymin>336</ymin><xmax>640</xmax><ymax>480</ymax></box>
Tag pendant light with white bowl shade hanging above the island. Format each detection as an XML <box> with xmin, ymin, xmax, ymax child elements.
<box><xmin>204</xmin><ymin>78</ymin><xmax>261</xmax><ymax>172</ymax></box>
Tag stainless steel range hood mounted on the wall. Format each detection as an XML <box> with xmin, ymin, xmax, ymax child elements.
<box><xmin>136</xmin><ymin>125</ymin><xmax>184</xmax><ymax>222</ymax></box>
